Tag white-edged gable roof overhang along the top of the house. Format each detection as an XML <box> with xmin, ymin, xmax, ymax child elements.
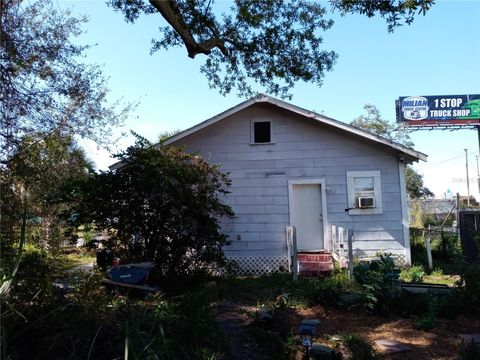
<box><xmin>163</xmin><ymin>94</ymin><xmax>427</xmax><ymax>163</ymax></box>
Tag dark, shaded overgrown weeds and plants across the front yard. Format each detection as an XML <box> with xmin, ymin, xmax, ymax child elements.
<box><xmin>4</xmin><ymin>246</ymin><xmax>479</xmax><ymax>359</ymax></box>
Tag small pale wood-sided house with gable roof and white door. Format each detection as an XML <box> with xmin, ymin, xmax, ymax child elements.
<box><xmin>164</xmin><ymin>94</ymin><xmax>426</xmax><ymax>272</ymax></box>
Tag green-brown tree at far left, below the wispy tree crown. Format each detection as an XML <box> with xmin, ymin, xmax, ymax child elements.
<box><xmin>0</xmin><ymin>132</ymin><xmax>93</xmax><ymax>247</ymax></box>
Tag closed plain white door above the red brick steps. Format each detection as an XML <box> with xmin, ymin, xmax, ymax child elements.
<box><xmin>290</xmin><ymin>183</ymin><xmax>324</xmax><ymax>251</ymax></box>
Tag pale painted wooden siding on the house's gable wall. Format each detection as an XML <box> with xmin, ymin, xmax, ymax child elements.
<box><xmin>172</xmin><ymin>104</ymin><xmax>404</xmax><ymax>256</ymax></box>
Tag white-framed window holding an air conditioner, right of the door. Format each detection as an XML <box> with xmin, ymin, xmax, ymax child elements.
<box><xmin>347</xmin><ymin>170</ymin><xmax>383</xmax><ymax>215</ymax></box>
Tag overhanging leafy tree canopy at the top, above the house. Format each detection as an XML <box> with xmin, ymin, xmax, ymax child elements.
<box><xmin>107</xmin><ymin>0</ymin><xmax>434</xmax><ymax>97</ymax></box>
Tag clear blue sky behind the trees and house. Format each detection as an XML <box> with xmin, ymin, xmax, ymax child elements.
<box><xmin>62</xmin><ymin>0</ymin><xmax>480</xmax><ymax>198</ymax></box>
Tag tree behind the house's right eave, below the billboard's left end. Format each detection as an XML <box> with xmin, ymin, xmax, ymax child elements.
<box><xmin>350</xmin><ymin>104</ymin><xmax>434</xmax><ymax>198</ymax></box>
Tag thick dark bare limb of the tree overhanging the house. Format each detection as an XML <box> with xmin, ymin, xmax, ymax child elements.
<box><xmin>150</xmin><ymin>0</ymin><xmax>228</xmax><ymax>59</ymax></box>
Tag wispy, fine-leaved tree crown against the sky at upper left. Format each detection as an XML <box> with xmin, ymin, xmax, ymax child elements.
<box><xmin>0</xmin><ymin>0</ymin><xmax>130</xmax><ymax>166</ymax></box>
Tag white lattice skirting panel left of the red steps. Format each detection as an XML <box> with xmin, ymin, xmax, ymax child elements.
<box><xmin>228</xmin><ymin>256</ymin><xmax>288</xmax><ymax>275</ymax></box>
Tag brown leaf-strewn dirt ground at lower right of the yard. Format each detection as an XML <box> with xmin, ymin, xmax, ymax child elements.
<box><xmin>215</xmin><ymin>302</ymin><xmax>480</xmax><ymax>360</ymax></box>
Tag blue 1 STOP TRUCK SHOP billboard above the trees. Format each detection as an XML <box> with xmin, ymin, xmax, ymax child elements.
<box><xmin>397</xmin><ymin>94</ymin><xmax>480</xmax><ymax>126</ymax></box>
